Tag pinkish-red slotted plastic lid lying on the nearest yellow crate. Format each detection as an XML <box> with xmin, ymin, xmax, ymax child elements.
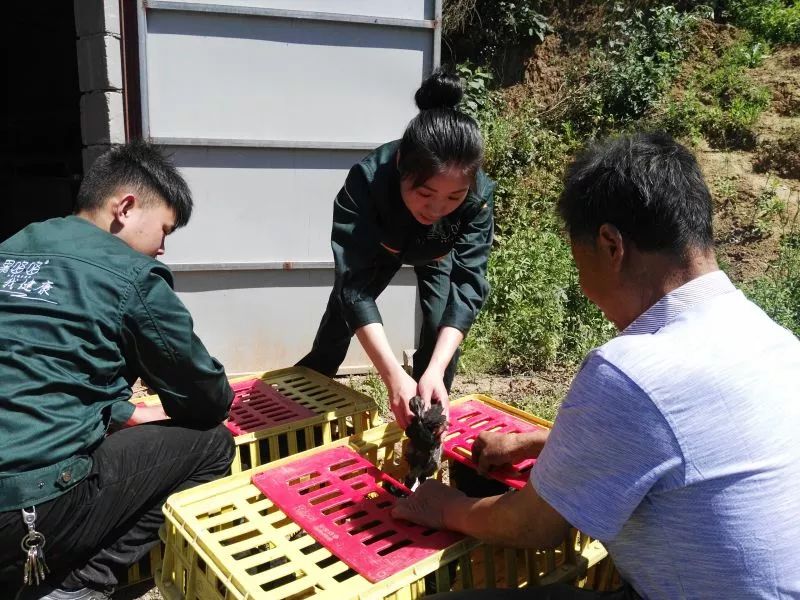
<box><xmin>252</xmin><ymin>447</ymin><xmax>464</xmax><ymax>583</ymax></box>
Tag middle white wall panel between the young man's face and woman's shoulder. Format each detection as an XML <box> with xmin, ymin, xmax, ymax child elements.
<box><xmin>165</xmin><ymin>148</ymin><xmax>366</xmax><ymax>262</ymax></box>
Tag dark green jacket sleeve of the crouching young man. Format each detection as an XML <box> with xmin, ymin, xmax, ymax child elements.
<box><xmin>122</xmin><ymin>267</ymin><xmax>233</xmax><ymax>423</ymax></box>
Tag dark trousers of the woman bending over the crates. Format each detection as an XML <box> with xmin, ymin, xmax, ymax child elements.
<box><xmin>297</xmin><ymin>254</ymin><xmax>461</xmax><ymax>391</ymax></box>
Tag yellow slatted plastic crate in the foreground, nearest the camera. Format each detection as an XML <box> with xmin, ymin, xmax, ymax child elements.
<box><xmin>156</xmin><ymin>395</ymin><xmax>606</xmax><ymax>600</ymax></box>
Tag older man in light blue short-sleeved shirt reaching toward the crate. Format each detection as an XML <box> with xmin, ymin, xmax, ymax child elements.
<box><xmin>396</xmin><ymin>135</ymin><xmax>800</xmax><ymax>600</ymax></box>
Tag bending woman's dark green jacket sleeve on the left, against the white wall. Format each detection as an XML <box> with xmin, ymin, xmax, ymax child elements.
<box><xmin>331</xmin><ymin>165</ymin><xmax>385</xmax><ymax>332</ymax></box>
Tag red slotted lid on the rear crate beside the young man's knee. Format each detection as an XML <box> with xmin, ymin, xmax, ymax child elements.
<box><xmin>225</xmin><ymin>379</ymin><xmax>316</xmax><ymax>435</ymax></box>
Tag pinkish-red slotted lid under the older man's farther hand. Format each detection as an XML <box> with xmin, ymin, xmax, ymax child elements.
<box><xmin>443</xmin><ymin>400</ymin><xmax>544</xmax><ymax>490</ymax></box>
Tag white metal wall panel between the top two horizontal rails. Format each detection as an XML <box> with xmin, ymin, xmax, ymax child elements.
<box><xmin>147</xmin><ymin>12</ymin><xmax>432</xmax><ymax>145</ymax></box>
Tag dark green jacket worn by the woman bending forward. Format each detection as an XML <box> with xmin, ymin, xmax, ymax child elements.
<box><xmin>331</xmin><ymin>141</ymin><xmax>495</xmax><ymax>334</ymax></box>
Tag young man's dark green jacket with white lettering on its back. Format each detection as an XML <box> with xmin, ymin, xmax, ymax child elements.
<box><xmin>0</xmin><ymin>216</ymin><xmax>233</xmax><ymax>511</ymax></box>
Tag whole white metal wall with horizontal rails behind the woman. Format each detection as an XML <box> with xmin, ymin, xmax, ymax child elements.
<box><xmin>139</xmin><ymin>0</ymin><xmax>441</xmax><ymax>372</ymax></box>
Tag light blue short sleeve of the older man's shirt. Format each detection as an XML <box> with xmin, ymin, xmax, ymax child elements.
<box><xmin>531</xmin><ymin>353</ymin><xmax>684</xmax><ymax>541</ymax></box>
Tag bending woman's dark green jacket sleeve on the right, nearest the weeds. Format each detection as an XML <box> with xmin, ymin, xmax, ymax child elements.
<box><xmin>439</xmin><ymin>194</ymin><xmax>494</xmax><ymax>335</ymax></box>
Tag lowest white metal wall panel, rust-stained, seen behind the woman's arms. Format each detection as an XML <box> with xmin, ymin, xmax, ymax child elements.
<box><xmin>170</xmin><ymin>269</ymin><xmax>416</xmax><ymax>373</ymax></box>
